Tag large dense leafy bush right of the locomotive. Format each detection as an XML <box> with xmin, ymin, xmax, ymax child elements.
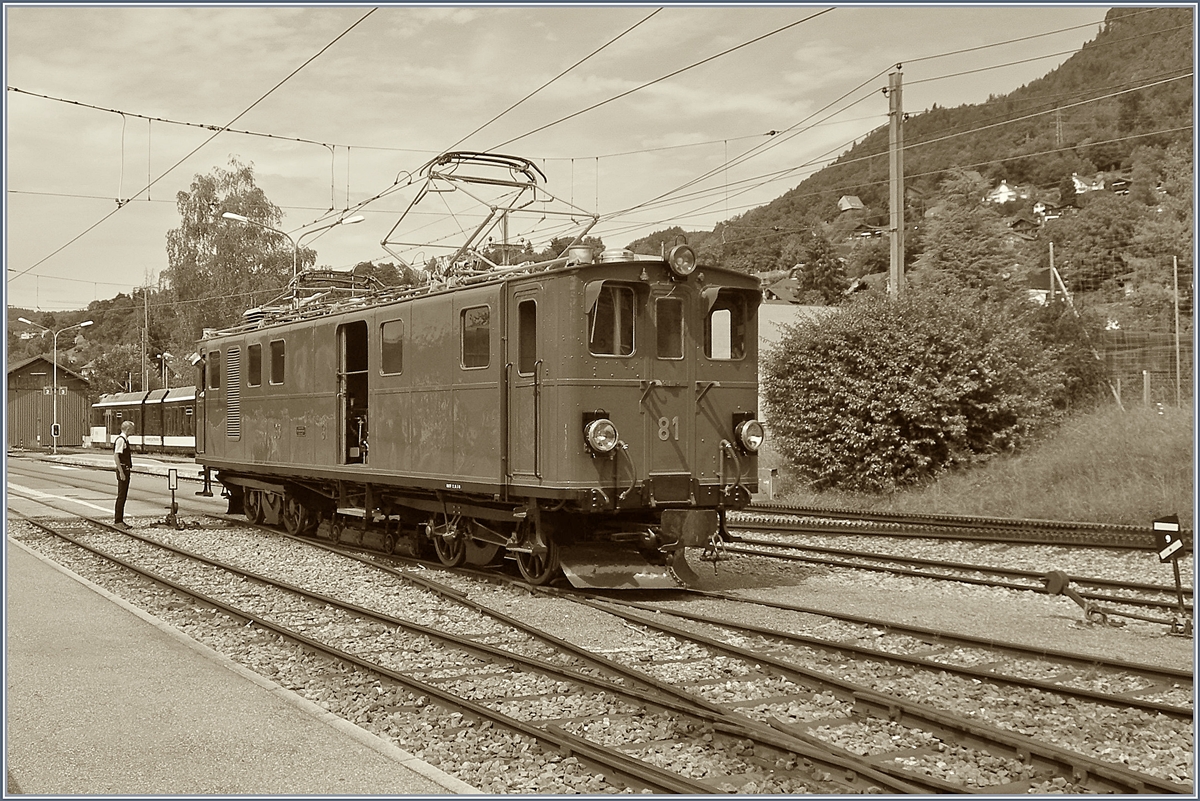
<box><xmin>763</xmin><ymin>289</ymin><xmax>1092</xmax><ymax>492</ymax></box>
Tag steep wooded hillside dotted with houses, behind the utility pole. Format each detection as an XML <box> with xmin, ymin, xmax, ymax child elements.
<box><xmin>630</xmin><ymin>8</ymin><xmax>1194</xmax><ymax>315</ymax></box>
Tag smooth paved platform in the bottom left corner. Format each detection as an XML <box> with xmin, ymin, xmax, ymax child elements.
<box><xmin>5</xmin><ymin>541</ymin><xmax>479</xmax><ymax>795</ymax></box>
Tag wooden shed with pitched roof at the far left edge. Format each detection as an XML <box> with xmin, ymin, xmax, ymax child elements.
<box><xmin>8</xmin><ymin>356</ymin><xmax>91</xmax><ymax>450</ymax></box>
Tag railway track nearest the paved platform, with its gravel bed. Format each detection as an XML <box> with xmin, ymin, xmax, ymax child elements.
<box><xmin>7</xmin><ymin>513</ymin><xmax>916</xmax><ymax>794</ymax></box>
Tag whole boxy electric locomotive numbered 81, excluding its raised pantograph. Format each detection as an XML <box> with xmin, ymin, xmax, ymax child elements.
<box><xmin>197</xmin><ymin>151</ymin><xmax>763</xmax><ymax>588</ymax></box>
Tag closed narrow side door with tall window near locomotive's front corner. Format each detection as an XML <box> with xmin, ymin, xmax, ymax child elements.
<box><xmin>505</xmin><ymin>287</ymin><xmax>544</xmax><ymax>480</ymax></box>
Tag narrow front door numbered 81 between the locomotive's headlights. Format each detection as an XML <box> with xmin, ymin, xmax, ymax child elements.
<box><xmin>642</xmin><ymin>291</ymin><xmax>695</xmax><ymax>502</ymax></box>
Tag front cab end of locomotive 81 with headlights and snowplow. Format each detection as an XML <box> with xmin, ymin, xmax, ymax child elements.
<box><xmin>510</xmin><ymin>242</ymin><xmax>762</xmax><ymax>586</ymax></box>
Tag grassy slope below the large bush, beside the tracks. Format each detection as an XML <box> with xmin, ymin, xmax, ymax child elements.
<box><xmin>764</xmin><ymin>406</ymin><xmax>1195</xmax><ymax>528</ymax></box>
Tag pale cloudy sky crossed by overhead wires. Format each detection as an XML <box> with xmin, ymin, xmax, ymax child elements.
<box><xmin>4</xmin><ymin>4</ymin><xmax>1108</xmax><ymax>311</ymax></box>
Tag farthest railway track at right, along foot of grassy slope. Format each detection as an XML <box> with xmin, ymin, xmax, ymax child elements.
<box><xmin>728</xmin><ymin>504</ymin><xmax>1193</xmax><ymax>550</ymax></box>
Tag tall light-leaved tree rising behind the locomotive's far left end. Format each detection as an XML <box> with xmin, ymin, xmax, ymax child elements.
<box><xmin>164</xmin><ymin>157</ymin><xmax>302</xmax><ymax>342</ymax></box>
